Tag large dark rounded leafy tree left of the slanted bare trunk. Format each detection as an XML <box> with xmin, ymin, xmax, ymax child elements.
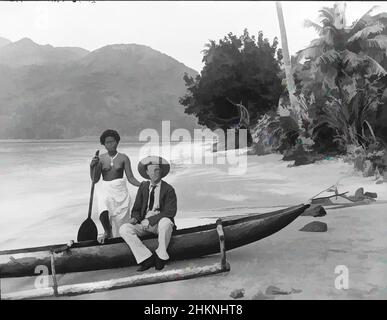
<box><xmin>180</xmin><ymin>30</ymin><xmax>283</xmax><ymax>134</ymax></box>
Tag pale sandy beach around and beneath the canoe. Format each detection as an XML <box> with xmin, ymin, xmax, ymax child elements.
<box><xmin>2</xmin><ymin>151</ymin><xmax>387</xmax><ymax>300</ymax></box>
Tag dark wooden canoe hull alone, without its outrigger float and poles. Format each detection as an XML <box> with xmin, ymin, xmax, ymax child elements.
<box><xmin>0</xmin><ymin>204</ymin><xmax>310</xmax><ymax>278</ymax></box>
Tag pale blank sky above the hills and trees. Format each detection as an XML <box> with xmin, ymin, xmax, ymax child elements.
<box><xmin>0</xmin><ymin>1</ymin><xmax>387</xmax><ymax>71</ymax></box>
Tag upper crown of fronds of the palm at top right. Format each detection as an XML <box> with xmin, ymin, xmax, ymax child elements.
<box><xmin>297</xmin><ymin>3</ymin><xmax>387</xmax><ymax>76</ymax></box>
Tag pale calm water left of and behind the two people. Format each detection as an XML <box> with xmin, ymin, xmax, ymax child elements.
<box><xmin>0</xmin><ymin>141</ymin><xmax>209</xmax><ymax>249</ymax></box>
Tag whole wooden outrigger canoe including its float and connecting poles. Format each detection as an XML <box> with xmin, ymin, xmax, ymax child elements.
<box><xmin>0</xmin><ymin>204</ymin><xmax>310</xmax><ymax>299</ymax></box>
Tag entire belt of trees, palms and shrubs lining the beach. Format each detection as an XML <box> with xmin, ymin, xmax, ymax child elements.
<box><xmin>180</xmin><ymin>3</ymin><xmax>387</xmax><ymax>178</ymax></box>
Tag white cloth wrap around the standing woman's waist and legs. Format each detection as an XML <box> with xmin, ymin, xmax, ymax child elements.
<box><xmin>97</xmin><ymin>178</ymin><xmax>131</xmax><ymax>237</ymax></box>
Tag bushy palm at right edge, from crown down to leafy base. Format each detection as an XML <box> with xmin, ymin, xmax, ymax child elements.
<box><xmin>297</xmin><ymin>3</ymin><xmax>387</xmax><ymax>148</ymax></box>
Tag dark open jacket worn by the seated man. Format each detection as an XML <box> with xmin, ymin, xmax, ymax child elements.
<box><xmin>132</xmin><ymin>180</ymin><xmax>177</xmax><ymax>226</ymax></box>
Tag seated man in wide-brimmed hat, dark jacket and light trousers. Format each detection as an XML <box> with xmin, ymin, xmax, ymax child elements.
<box><xmin>119</xmin><ymin>156</ymin><xmax>177</xmax><ymax>271</ymax></box>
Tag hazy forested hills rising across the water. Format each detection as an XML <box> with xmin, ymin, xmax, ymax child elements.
<box><xmin>0</xmin><ymin>38</ymin><xmax>197</xmax><ymax>139</ymax></box>
